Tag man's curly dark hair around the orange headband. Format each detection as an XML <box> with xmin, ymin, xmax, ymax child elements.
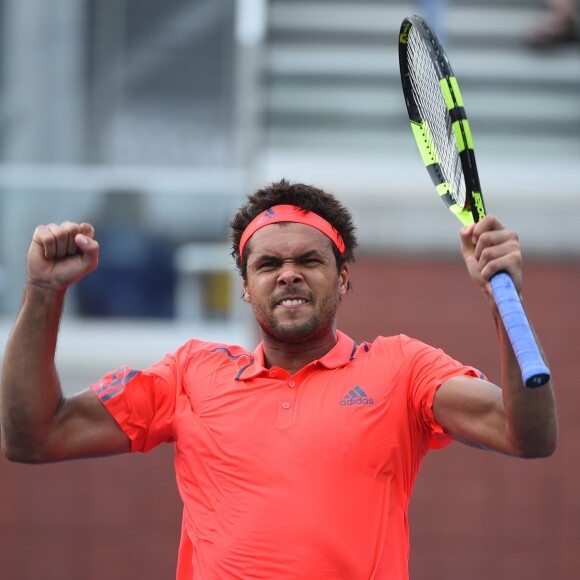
<box><xmin>229</xmin><ymin>179</ymin><xmax>357</xmax><ymax>279</ymax></box>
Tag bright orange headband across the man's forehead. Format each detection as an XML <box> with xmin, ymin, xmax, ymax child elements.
<box><xmin>240</xmin><ymin>205</ymin><xmax>346</xmax><ymax>259</ymax></box>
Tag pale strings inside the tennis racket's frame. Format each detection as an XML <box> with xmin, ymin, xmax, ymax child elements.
<box><xmin>407</xmin><ymin>27</ymin><xmax>466</xmax><ymax>207</ymax></box>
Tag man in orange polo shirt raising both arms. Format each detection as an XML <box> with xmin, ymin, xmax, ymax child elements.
<box><xmin>1</xmin><ymin>181</ymin><xmax>557</xmax><ymax>580</ymax></box>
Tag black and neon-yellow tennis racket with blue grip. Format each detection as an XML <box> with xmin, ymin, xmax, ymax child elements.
<box><xmin>399</xmin><ymin>16</ymin><xmax>550</xmax><ymax>387</ymax></box>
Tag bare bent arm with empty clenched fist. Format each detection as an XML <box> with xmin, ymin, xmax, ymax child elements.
<box><xmin>0</xmin><ymin>222</ymin><xmax>129</xmax><ymax>463</ymax></box>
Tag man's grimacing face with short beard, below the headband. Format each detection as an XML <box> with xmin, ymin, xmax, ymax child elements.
<box><xmin>244</xmin><ymin>223</ymin><xmax>348</xmax><ymax>343</ymax></box>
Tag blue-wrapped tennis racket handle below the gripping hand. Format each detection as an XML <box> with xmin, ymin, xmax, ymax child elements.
<box><xmin>490</xmin><ymin>272</ymin><xmax>550</xmax><ymax>388</ymax></box>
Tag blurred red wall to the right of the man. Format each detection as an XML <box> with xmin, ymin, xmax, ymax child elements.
<box><xmin>340</xmin><ymin>259</ymin><xmax>580</xmax><ymax>580</ymax></box>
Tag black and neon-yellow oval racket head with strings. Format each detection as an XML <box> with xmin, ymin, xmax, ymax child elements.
<box><xmin>399</xmin><ymin>15</ymin><xmax>485</xmax><ymax>225</ymax></box>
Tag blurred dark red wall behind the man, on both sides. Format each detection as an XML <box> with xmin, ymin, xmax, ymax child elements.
<box><xmin>0</xmin><ymin>258</ymin><xmax>580</xmax><ymax>580</ymax></box>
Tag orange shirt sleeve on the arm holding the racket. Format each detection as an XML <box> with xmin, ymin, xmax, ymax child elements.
<box><xmin>403</xmin><ymin>337</ymin><xmax>485</xmax><ymax>449</ymax></box>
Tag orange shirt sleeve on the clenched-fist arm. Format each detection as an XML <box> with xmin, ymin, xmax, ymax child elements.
<box><xmin>90</xmin><ymin>354</ymin><xmax>181</xmax><ymax>452</ymax></box>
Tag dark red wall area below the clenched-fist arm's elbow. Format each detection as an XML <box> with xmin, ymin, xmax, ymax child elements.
<box><xmin>0</xmin><ymin>446</ymin><xmax>181</xmax><ymax>580</ymax></box>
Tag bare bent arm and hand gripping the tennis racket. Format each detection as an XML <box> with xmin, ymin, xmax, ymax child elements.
<box><xmin>433</xmin><ymin>216</ymin><xmax>558</xmax><ymax>457</ymax></box>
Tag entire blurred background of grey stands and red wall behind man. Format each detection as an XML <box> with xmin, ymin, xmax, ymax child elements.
<box><xmin>0</xmin><ymin>0</ymin><xmax>580</xmax><ymax>580</ymax></box>
